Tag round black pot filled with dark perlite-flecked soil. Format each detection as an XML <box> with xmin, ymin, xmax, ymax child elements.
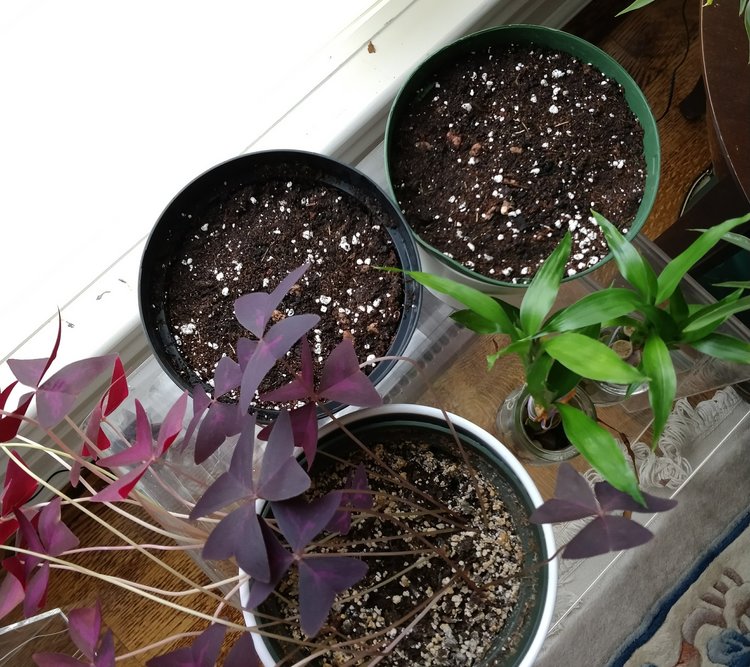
<box><xmin>139</xmin><ymin>150</ymin><xmax>421</xmax><ymax>418</ymax></box>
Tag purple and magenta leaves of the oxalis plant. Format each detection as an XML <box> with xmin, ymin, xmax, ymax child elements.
<box><xmin>0</xmin><ymin>265</ymin><xmax>674</xmax><ymax>667</ymax></box>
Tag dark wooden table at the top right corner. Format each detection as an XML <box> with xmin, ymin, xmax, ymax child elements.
<box><xmin>656</xmin><ymin>0</ymin><xmax>750</xmax><ymax>270</ymax></box>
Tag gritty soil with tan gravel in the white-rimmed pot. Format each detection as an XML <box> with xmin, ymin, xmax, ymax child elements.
<box><xmin>261</xmin><ymin>435</ymin><xmax>534</xmax><ymax>667</ymax></box>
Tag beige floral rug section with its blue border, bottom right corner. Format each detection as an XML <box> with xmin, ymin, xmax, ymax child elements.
<box><xmin>611</xmin><ymin>510</ymin><xmax>750</xmax><ymax>667</ymax></box>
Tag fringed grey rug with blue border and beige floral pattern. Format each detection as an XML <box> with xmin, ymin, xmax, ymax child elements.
<box><xmin>535</xmin><ymin>390</ymin><xmax>750</xmax><ymax>667</ymax></box>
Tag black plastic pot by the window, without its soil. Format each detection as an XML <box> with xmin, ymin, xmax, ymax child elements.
<box><xmin>139</xmin><ymin>150</ymin><xmax>421</xmax><ymax>412</ymax></box>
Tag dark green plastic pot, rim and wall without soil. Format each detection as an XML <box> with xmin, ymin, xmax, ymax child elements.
<box><xmin>385</xmin><ymin>25</ymin><xmax>661</xmax><ymax>293</ymax></box>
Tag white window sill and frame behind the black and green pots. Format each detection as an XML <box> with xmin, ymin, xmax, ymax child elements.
<box><xmin>0</xmin><ymin>0</ymin><xmax>590</xmax><ymax>490</ymax></box>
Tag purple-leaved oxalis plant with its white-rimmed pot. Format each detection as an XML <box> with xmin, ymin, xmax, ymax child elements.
<box><xmin>0</xmin><ymin>260</ymin><xmax>680</xmax><ymax>667</ymax></box>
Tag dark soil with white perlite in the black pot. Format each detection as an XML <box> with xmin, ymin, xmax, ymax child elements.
<box><xmin>165</xmin><ymin>174</ymin><xmax>403</xmax><ymax>400</ymax></box>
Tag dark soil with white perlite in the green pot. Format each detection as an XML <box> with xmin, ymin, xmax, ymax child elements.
<box><xmin>390</xmin><ymin>45</ymin><xmax>645</xmax><ymax>283</ymax></box>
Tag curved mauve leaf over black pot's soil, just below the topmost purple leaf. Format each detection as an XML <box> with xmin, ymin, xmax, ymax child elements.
<box><xmin>240</xmin><ymin>315</ymin><xmax>320</xmax><ymax>412</ymax></box>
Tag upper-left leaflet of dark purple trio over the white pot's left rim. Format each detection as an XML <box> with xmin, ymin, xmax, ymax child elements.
<box><xmin>190</xmin><ymin>415</ymin><xmax>256</xmax><ymax>519</ymax></box>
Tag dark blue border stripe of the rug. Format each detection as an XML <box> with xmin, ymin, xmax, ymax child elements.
<box><xmin>607</xmin><ymin>508</ymin><xmax>750</xmax><ymax>667</ymax></box>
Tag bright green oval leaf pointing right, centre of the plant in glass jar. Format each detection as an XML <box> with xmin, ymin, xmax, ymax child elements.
<box><xmin>542</xmin><ymin>333</ymin><xmax>647</xmax><ymax>384</ymax></box>
